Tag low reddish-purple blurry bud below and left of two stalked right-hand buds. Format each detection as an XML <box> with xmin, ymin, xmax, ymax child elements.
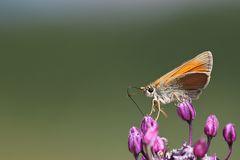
<box><xmin>193</xmin><ymin>138</ymin><xmax>208</xmax><ymax>158</ymax></box>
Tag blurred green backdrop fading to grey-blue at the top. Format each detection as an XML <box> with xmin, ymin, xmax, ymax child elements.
<box><xmin>0</xmin><ymin>0</ymin><xmax>240</xmax><ymax>160</ymax></box>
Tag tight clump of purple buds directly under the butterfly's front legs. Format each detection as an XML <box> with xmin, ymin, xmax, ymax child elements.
<box><xmin>128</xmin><ymin>116</ymin><xmax>167</xmax><ymax>159</ymax></box>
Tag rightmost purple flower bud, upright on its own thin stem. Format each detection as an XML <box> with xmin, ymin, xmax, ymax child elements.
<box><xmin>223</xmin><ymin>123</ymin><xmax>237</xmax><ymax>146</ymax></box>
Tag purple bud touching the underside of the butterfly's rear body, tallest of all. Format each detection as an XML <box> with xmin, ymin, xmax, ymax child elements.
<box><xmin>177</xmin><ymin>101</ymin><xmax>196</xmax><ymax>122</ymax></box>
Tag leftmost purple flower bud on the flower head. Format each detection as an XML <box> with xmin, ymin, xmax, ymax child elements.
<box><xmin>128</xmin><ymin>127</ymin><xmax>142</xmax><ymax>156</ymax></box>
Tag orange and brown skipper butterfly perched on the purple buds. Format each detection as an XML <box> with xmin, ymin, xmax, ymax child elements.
<box><xmin>128</xmin><ymin>51</ymin><xmax>213</xmax><ymax>120</ymax></box>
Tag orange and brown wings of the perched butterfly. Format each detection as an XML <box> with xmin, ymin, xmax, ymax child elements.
<box><xmin>151</xmin><ymin>51</ymin><xmax>213</xmax><ymax>90</ymax></box>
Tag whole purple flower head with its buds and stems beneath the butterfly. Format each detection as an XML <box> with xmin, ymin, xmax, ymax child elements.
<box><xmin>128</xmin><ymin>101</ymin><xmax>236</xmax><ymax>160</ymax></box>
